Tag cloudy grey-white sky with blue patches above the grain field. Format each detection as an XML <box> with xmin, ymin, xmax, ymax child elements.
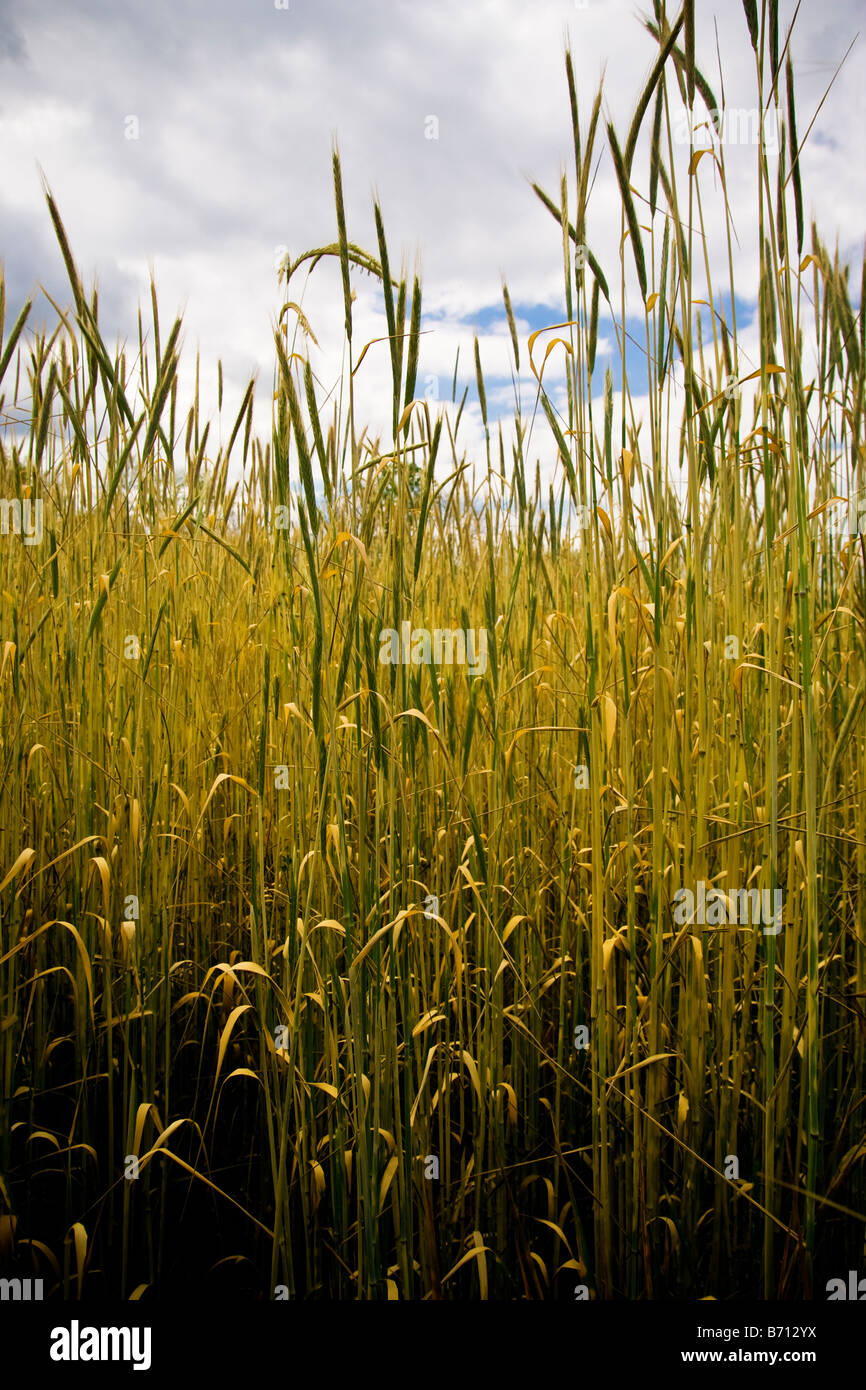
<box><xmin>0</xmin><ymin>0</ymin><xmax>866</xmax><ymax>497</ymax></box>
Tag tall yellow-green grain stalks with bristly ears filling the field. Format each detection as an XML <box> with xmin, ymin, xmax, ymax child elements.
<box><xmin>0</xmin><ymin>0</ymin><xmax>866</xmax><ymax>1298</ymax></box>
